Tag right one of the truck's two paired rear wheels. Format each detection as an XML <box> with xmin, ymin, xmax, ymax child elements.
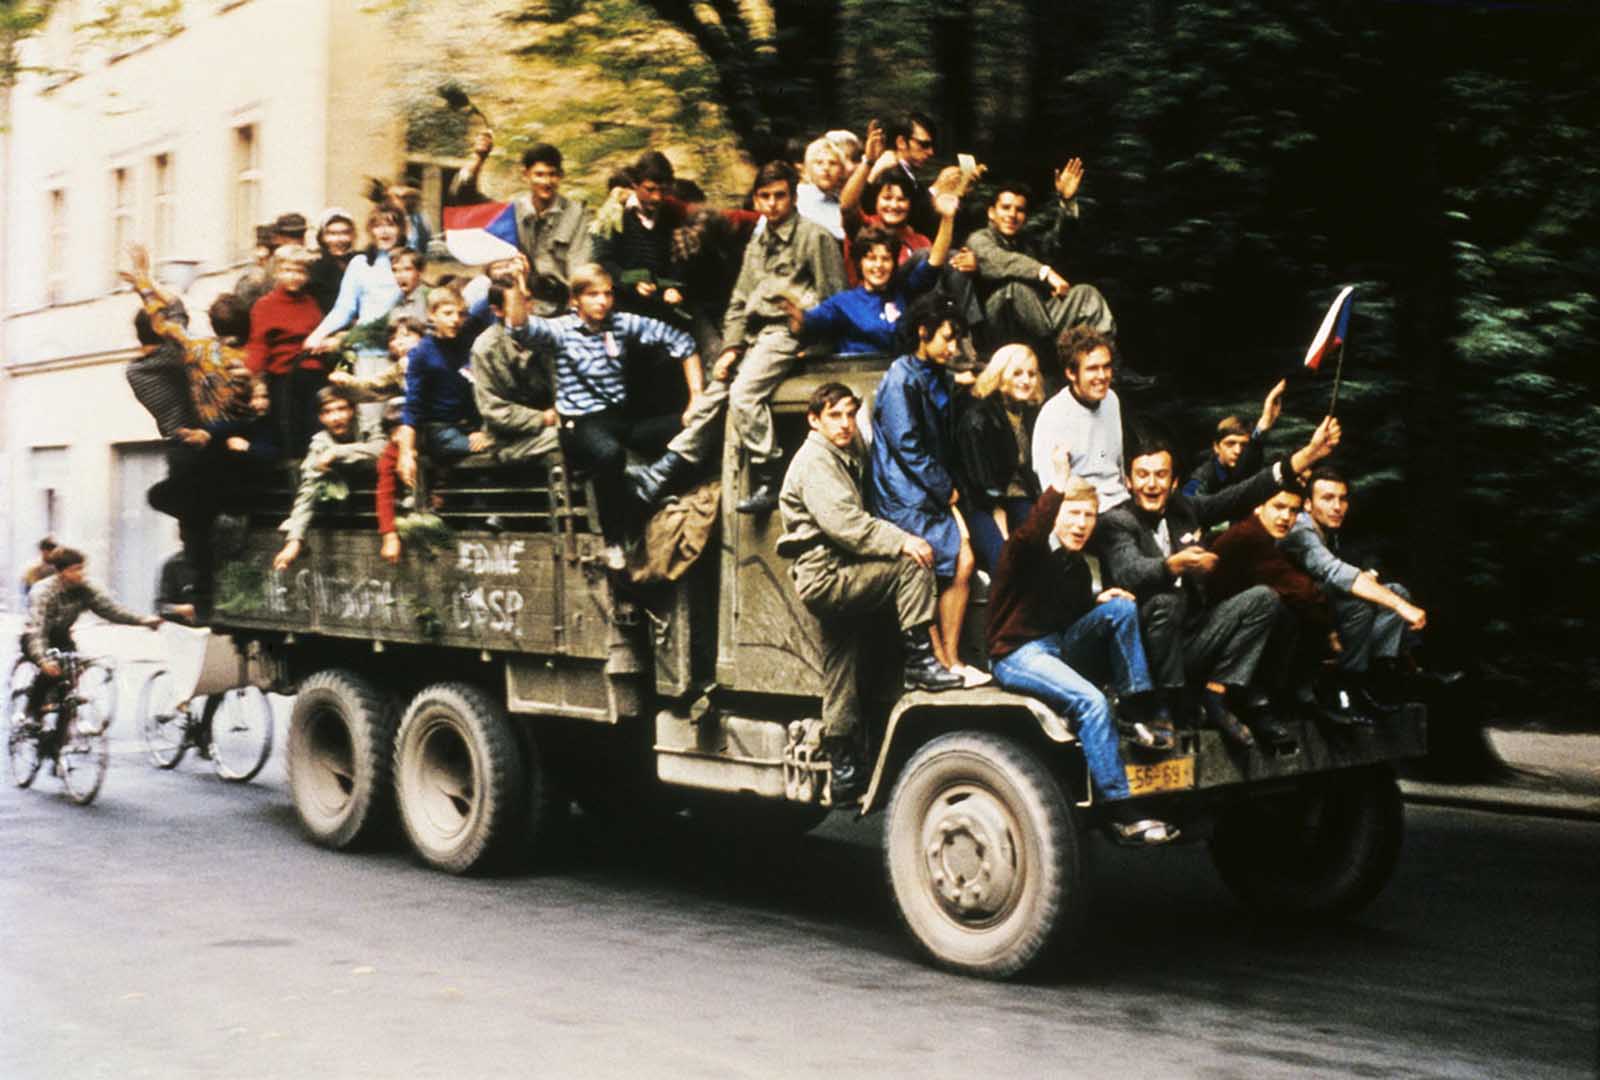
<box><xmin>395</xmin><ymin>683</ymin><xmax>528</xmax><ymax>874</ymax></box>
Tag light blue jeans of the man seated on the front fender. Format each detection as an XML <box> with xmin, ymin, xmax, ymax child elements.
<box><xmin>994</xmin><ymin>598</ymin><xmax>1150</xmax><ymax>800</ymax></box>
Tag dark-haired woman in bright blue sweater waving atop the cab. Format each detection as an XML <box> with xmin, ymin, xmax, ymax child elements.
<box><xmin>779</xmin><ymin>187</ymin><xmax>962</xmax><ymax>357</ymax></box>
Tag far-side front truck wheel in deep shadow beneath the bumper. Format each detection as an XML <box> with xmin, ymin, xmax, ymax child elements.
<box><xmin>1211</xmin><ymin>766</ymin><xmax>1405</xmax><ymax>918</ymax></box>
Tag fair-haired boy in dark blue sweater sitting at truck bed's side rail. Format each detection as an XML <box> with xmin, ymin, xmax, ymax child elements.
<box><xmin>395</xmin><ymin>285</ymin><xmax>494</xmax><ymax>485</ymax></box>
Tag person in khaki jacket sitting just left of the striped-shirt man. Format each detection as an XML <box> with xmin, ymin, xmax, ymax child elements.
<box><xmin>472</xmin><ymin>275</ymin><xmax>560</xmax><ymax>462</ymax></box>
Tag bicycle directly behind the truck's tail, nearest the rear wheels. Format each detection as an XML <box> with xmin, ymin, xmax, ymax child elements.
<box><xmin>139</xmin><ymin>667</ymin><xmax>272</xmax><ymax>784</ymax></box>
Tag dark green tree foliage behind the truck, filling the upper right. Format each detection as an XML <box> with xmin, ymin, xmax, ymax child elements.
<box><xmin>556</xmin><ymin>0</ymin><xmax>1600</xmax><ymax>722</ymax></box>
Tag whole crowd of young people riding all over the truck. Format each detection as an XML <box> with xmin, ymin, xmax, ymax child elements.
<box><xmin>128</xmin><ymin>114</ymin><xmax>1452</xmax><ymax>843</ymax></box>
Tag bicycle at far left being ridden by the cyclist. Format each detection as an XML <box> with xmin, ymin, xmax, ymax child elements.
<box><xmin>6</xmin><ymin>650</ymin><xmax>117</xmax><ymax>806</ymax></box>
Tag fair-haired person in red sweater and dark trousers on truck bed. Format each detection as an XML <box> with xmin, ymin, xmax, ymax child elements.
<box><xmin>245</xmin><ymin>245</ymin><xmax>328</xmax><ymax>458</ymax></box>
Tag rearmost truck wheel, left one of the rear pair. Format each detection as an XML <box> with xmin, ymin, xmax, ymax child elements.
<box><xmin>286</xmin><ymin>669</ymin><xmax>395</xmax><ymax>851</ymax></box>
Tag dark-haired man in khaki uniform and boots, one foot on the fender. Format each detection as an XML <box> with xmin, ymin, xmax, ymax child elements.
<box><xmin>778</xmin><ymin>382</ymin><xmax>963</xmax><ymax>802</ymax></box>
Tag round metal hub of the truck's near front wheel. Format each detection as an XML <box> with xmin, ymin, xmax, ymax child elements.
<box><xmin>923</xmin><ymin>790</ymin><xmax>1021</xmax><ymax>922</ymax></box>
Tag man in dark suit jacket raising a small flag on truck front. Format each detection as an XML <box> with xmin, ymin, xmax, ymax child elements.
<box><xmin>1101</xmin><ymin>416</ymin><xmax>1339</xmax><ymax>747</ymax></box>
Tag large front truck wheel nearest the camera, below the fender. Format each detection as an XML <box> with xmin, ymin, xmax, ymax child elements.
<box><xmin>885</xmin><ymin>731</ymin><xmax>1085</xmax><ymax>978</ymax></box>
